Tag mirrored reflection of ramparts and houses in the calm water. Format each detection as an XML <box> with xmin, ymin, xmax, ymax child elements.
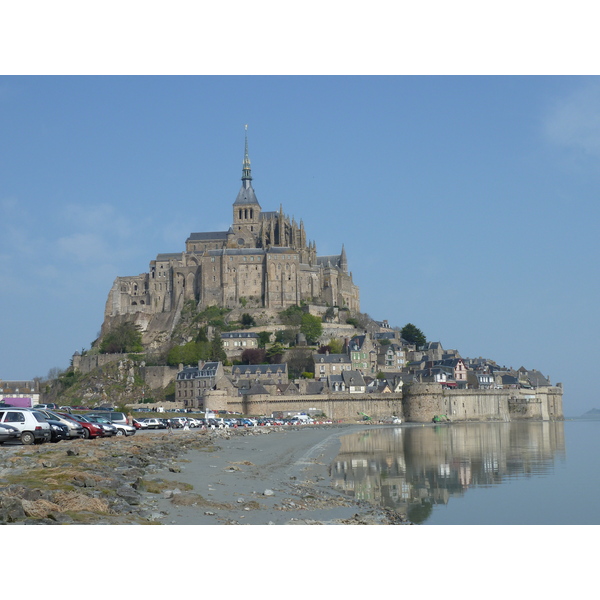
<box><xmin>332</xmin><ymin>421</ymin><xmax>565</xmax><ymax>523</ymax></box>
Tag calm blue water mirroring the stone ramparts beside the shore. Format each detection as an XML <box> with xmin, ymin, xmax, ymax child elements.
<box><xmin>332</xmin><ymin>419</ymin><xmax>600</xmax><ymax>525</ymax></box>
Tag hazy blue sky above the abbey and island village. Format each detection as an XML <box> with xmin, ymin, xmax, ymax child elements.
<box><xmin>0</xmin><ymin>76</ymin><xmax>600</xmax><ymax>415</ymax></box>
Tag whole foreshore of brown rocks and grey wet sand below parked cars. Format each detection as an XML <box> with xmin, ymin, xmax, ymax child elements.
<box><xmin>0</xmin><ymin>425</ymin><xmax>407</xmax><ymax>525</ymax></box>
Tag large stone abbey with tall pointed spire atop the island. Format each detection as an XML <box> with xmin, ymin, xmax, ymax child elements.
<box><xmin>105</xmin><ymin>133</ymin><xmax>360</xmax><ymax>321</ymax></box>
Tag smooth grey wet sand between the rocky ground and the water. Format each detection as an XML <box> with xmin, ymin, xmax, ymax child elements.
<box><xmin>148</xmin><ymin>425</ymin><xmax>410</xmax><ymax>525</ymax></box>
